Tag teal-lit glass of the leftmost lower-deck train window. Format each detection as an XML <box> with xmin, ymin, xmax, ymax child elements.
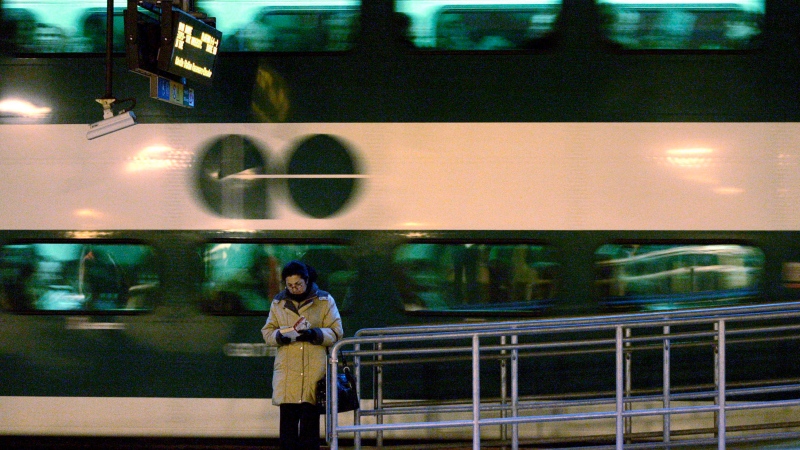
<box><xmin>0</xmin><ymin>243</ymin><xmax>159</xmax><ymax>312</ymax></box>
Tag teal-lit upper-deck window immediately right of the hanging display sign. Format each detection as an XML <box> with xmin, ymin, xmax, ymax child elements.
<box><xmin>195</xmin><ymin>0</ymin><xmax>361</xmax><ymax>52</ymax></box>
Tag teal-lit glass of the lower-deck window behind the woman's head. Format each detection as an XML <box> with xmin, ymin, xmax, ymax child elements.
<box><xmin>203</xmin><ymin>243</ymin><xmax>355</xmax><ymax>314</ymax></box>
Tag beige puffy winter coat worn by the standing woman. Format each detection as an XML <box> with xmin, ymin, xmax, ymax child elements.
<box><xmin>261</xmin><ymin>286</ymin><xmax>344</xmax><ymax>405</ymax></box>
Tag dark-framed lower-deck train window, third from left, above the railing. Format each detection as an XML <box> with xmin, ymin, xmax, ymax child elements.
<box><xmin>391</xmin><ymin>239</ymin><xmax>564</xmax><ymax>318</ymax></box>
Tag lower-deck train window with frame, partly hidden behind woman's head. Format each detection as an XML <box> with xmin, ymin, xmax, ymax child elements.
<box><xmin>198</xmin><ymin>239</ymin><xmax>356</xmax><ymax>317</ymax></box>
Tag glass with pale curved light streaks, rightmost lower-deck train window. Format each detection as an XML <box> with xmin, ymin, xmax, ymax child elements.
<box><xmin>595</xmin><ymin>244</ymin><xmax>764</xmax><ymax>310</ymax></box>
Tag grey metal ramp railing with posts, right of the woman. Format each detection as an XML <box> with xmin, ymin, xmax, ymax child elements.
<box><xmin>326</xmin><ymin>303</ymin><xmax>800</xmax><ymax>450</ymax></box>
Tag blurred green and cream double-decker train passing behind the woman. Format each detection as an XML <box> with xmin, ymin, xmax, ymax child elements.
<box><xmin>0</xmin><ymin>0</ymin><xmax>800</xmax><ymax>437</ymax></box>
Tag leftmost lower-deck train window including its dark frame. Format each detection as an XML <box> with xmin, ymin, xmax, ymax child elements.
<box><xmin>0</xmin><ymin>239</ymin><xmax>163</xmax><ymax>316</ymax></box>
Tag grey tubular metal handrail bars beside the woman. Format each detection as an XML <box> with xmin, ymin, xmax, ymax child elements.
<box><xmin>326</xmin><ymin>302</ymin><xmax>800</xmax><ymax>450</ymax></box>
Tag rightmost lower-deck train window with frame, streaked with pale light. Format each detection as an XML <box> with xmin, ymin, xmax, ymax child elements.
<box><xmin>592</xmin><ymin>240</ymin><xmax>767</xmax><ymax>313</ymax></box>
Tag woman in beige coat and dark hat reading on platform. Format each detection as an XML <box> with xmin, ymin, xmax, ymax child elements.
<box><xmin>261</xmin><ymin>261</ymin><xmax>344</xmax><ymax>450</ymax></box>
